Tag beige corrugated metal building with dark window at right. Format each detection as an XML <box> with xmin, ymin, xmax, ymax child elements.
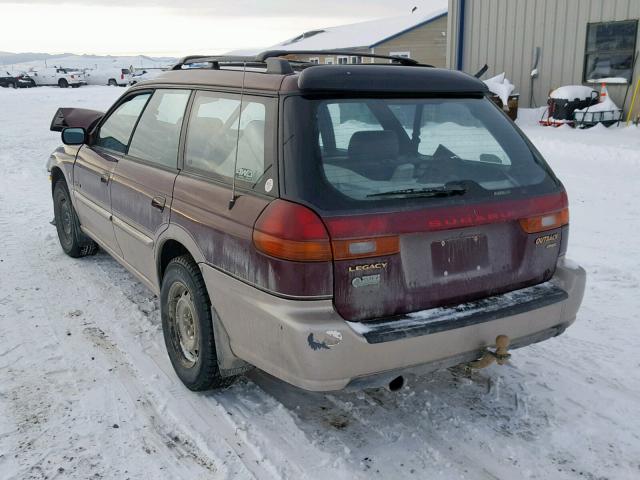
<box><xmin>447</xmin><ymin>0</ymin><xmax>640</xmax><ymax>115</ymax></box>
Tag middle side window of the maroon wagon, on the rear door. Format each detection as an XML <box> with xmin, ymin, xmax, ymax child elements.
<box><xmin>128</xmin><ymin>90</ymin><xmax>191</xmax><ymax>168</ymax></box>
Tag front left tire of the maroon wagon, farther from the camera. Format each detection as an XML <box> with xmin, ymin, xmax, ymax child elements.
<box><xmin>53</xmin><ymin>180</ymin><xmax>98</xmax><ymax>258</ymax></box>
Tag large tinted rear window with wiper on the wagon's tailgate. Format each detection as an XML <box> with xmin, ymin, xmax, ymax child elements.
<box><xmin>285</xmin><ymin>97</ymin><xmax>556</xmax><ymax>212</ymax></box>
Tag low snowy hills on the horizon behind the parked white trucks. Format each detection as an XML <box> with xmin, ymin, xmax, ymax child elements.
<box><xmin>0</xmin><ymin>52</ymin><xmax>177</xmax><ymax>71</ymax></box>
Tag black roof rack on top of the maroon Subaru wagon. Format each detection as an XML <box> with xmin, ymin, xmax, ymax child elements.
<box><xmin>171</xmin><ymin>50</ymin><xmax>433</xmax><ymax>75</ymax></box>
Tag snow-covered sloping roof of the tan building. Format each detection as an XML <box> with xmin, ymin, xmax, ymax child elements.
<box><xmin>270</xmin><ymin>0</ymin><xmax>447</xmax><ymax>50</ymax></box>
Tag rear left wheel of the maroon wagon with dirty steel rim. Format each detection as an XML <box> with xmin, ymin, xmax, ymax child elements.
<box><xmin>160</xmin><ymin>255</ymin><xmax>235</xmax><ymax>391</ymax></box>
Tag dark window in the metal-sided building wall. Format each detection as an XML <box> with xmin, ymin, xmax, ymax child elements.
<box><xmin>583</xmin><ymin>20</ymin><xmax>638</xmax><ymax>82</ymax></box>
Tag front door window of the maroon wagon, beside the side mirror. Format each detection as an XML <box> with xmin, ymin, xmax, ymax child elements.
<box><xmin>94</xmin><ymin>93</ymin><xmax>151</xmax><ymax>153</ymax></box>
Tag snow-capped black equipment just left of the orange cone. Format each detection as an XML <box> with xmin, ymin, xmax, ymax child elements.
<box><xmin>540</xmin><ymin>85</ymin><xmax>600</xmax><ymax>127</ymax></box>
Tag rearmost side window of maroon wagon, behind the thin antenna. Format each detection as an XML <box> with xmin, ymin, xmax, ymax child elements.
<box><xmin>184</xmin><ymin>91</ymin><xmax>270</xmax><ymax>185</ymax></box>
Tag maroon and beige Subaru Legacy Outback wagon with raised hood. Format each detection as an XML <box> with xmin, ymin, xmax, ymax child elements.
<box><xmin>48</xmin><ymin>52</ymin><xmax>585</xmax><ymax>391</ymax></box>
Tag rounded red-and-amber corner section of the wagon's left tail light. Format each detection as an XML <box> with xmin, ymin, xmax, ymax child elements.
<box><xmin>253</xmin><ymin>200</ymin><xmax>333</xmax><ymax>262</ymax></box>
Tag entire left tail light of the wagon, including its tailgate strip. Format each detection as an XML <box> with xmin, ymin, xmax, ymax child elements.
<box><xmin>253</xmin><ymin>200</ymin><xmax>400</xmax><ymax>262</ymax></box>
